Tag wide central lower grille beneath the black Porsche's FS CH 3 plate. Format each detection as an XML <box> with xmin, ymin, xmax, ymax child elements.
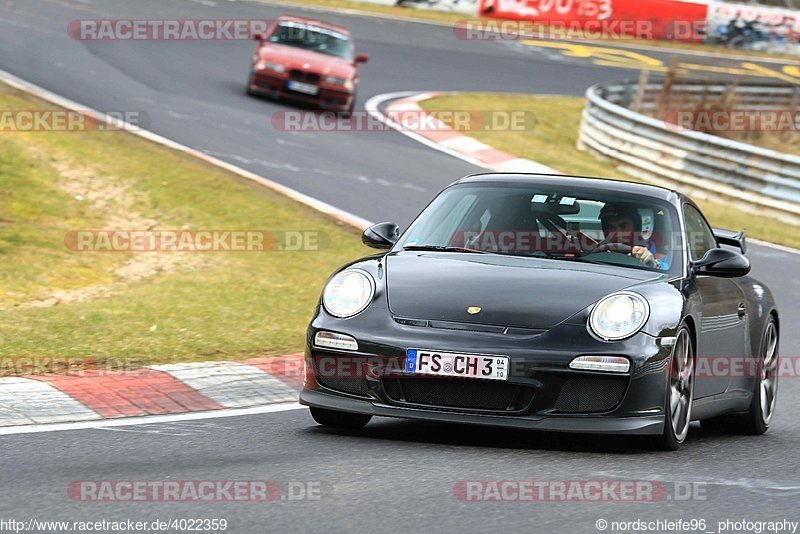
<box><xmin>382</xmin><ymin>377</ymin><xmax>533</xmax><ymax>412</ymax></box>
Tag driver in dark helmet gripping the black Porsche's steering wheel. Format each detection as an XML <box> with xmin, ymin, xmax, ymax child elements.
<box><xmin>599</xmin><ymin>203</ymin><xmax>670</xmax><ymax>270</ymax></box>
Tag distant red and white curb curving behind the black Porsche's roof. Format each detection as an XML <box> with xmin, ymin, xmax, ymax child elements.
<box><xmin>365</xmin><ymin>92</ymin><xmax>563</xmax><ymax>174</ymax></box>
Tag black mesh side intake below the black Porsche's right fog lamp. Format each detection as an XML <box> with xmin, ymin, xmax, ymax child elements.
<box><xmin>554</xmin><ymin>376</ymin><xmax>628</xmax><ymax>413</ymax></box>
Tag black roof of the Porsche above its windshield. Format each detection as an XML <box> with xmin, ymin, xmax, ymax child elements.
<box><xmin>451</xmin><ymin>173</ymin><xmax>678</xmax><ymax>201</ymax></box>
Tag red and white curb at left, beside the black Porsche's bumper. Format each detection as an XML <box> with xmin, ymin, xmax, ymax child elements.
<box><xmin>0</xmin><ymin>354</ymin><xmax>304</xmax><ymax>427</ymax></box>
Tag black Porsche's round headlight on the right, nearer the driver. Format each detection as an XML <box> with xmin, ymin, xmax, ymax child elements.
<box><xmin>589</xmin><ymin>291</ymin><xmax>650</xmax><ymax>341</ymax></box>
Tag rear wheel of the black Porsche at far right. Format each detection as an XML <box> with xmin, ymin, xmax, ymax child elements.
<box><xmin>700</xmin><ymin>317</ymin><xmax>779</xmax><ymax>436</ymax></box>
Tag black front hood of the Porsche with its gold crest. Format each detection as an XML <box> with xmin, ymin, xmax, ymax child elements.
<box><xmin>386</xmin><ymin>251</ymin><xmax>663</xmax><ymax>329</ymax></box>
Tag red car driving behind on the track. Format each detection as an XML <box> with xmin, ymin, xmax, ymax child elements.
<box><xmin>247</xmin><ymin>15</ymin><xmax>368</xmax><ymax>112</ymax></box>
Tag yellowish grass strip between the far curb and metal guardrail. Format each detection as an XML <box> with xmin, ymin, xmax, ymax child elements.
<box><xmin>420</xmin><ymin>93</ymin><xmax>800</xmax><ymax>248</ymax></box>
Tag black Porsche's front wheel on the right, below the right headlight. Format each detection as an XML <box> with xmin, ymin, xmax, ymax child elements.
<box><xmin>650</xmin><ymin>323</ymin><xmax>694</xmax><ymax>451</ymax></box>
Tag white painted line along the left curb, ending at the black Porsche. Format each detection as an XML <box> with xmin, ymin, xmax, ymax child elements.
<box><xmin>0</xmin><ymin>402</ymin><xmax>305</xmax><ymax>436</ymax></box>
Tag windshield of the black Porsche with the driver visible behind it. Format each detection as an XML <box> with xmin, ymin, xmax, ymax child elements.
<box><xmin>398</xmin><ymin>184</ymin><xmax>683</xmax><ymax>273</ymax></box>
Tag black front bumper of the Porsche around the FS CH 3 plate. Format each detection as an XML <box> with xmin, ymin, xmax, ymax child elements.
<box><xmin>300</xmin><ymin>305</ymin><xmax>672</xmax><ymax>435</ymax></box>
